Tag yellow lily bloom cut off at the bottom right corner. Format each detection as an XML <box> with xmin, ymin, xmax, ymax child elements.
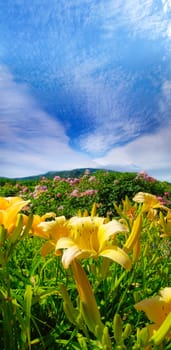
<box><xmin>134</xmin><ymin>287</ymin><xmax>171</xmax><ymax>338</ymax></box>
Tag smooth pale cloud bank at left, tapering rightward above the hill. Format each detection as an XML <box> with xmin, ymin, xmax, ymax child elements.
<box><xmin>0</xmin><ymin>67</ymin><xmax>96</xmax><ymax>177</ymax></box>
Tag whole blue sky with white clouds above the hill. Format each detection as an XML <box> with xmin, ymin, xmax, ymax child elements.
<box><xmin>0</xmin><ymin>0</ymin><xmax>171</xmax><ymax>181</ymax></box>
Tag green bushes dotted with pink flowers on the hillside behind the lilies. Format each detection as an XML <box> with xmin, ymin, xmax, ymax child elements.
<box><xmin>0</xmin><ymin>170</ymin><xmax>171</xmax><ymax>218</ymax></box>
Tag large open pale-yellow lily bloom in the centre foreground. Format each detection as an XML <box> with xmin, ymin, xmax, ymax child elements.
<box><xmin>56</xmin><ymin>216</ymin><xmax>131</xmax><ymax>269</ymax></box>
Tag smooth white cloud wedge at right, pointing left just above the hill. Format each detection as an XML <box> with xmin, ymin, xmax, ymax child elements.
<box><xmin>94</xmin><ymin>125</ymin><xmax>171</xmax><ymax>181</ymax></box>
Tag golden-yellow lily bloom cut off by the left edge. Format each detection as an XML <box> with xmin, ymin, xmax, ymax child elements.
<box><xmin>0</xmin><ymin>197</ymin><xmax>29</xmax><ymax>234</ymax></box>
